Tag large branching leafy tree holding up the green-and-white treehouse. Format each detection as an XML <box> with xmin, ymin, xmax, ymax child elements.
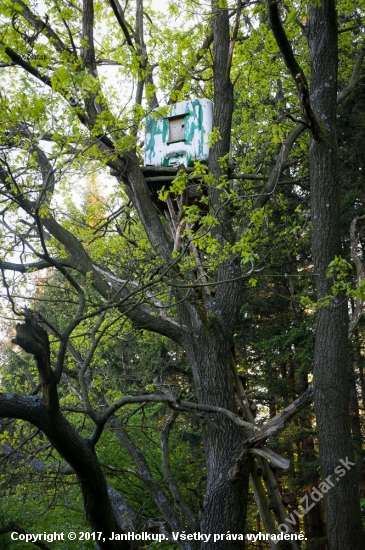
<box><xmin>0</xmin><ymin>0</ymin><xmax>364</xmax><ymax>550</ymax></box>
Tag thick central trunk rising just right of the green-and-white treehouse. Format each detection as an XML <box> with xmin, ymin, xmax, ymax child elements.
<box><xmin>183</xmin><ymin>0</ymin><xmax>251</xmax><ymax>550</ymax></box>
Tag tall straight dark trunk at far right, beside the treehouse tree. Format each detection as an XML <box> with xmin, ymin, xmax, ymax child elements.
<box><xmin>308</xmin><ymin>0</ymin><xmax>365</xmax><ymax>550</ymax></box>
